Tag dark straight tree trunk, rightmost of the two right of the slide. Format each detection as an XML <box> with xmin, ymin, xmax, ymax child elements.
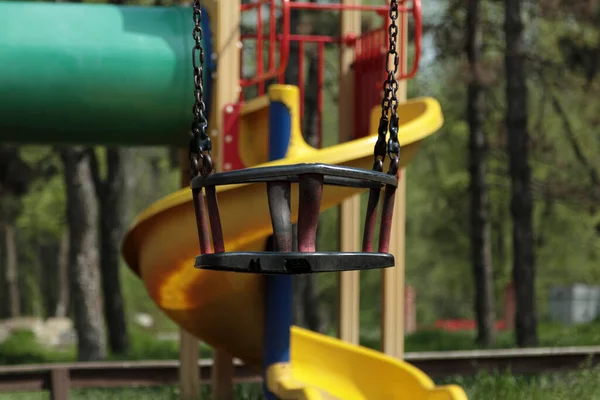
<box><xmin>504</xmin><ymin>0</ymin><xmax>537</xmax><ymax>346</ymax></box>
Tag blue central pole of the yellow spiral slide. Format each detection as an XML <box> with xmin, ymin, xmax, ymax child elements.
<box><xmin>264</xmin><ymin>101</ymin><xmax>293</xmax><ymax>400</ymax></box>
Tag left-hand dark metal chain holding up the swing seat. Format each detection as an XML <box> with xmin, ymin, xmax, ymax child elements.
<box><xmin>189</xmin><ymin>0</ymin><xmax>213</xmax><ymax>178</ymax></box>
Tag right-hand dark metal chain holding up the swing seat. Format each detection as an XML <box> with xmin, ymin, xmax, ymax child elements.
<box><xmin>373</xmin><ymin>0</ymin><xmax>400</xmax><ymax>175</ymax></box>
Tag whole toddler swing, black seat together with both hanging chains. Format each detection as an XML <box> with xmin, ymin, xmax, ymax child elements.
<box><xmin>189</xmin><ymin>0</ymin><xmax>400</xmax><ymax>274</ymax></box>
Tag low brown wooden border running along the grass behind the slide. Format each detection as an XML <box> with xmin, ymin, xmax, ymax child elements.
<box><xmin>0</xmin><ymin>346</ymin><xmax>600</xmax><ymax>400</ymax></box>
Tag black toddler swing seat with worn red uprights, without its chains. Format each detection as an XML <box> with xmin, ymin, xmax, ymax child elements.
<box><xmin>191</xmin><ymin>163</ymin><xmax>398</xmax><ymax>274</ymax></box>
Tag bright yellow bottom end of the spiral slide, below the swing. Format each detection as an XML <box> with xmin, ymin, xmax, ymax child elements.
<box><xmin>267</xmin><ymin>327</ymin><xmax>467</xmax><ymax>400</ymax></box>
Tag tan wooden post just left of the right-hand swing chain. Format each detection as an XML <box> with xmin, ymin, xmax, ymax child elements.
<box><xmin>338</xmin><ymin>0</ymin><xmax>361</xmax><ymax>344</ymax></box>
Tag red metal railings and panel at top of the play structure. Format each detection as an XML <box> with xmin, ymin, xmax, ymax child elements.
<box><xmin>240</xmin><ymin>0</ymin><xmax>422</xmax><ymax>146</ymax></box>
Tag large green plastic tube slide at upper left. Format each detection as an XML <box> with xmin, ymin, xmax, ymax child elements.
<box><xmin>0</xmin><ymin>1</ymin><xmax>213</xmax><ymax>146</ymax></box>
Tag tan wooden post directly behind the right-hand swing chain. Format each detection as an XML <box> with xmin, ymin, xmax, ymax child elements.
<box><xmin>381</xmin><ymin>0</ymin><xmax>408</xmax><ymax>358</ymax></box>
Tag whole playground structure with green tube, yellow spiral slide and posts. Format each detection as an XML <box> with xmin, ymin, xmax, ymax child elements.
<box><xmin>0</xmin><ymin>0</ymin><xmax>465</xmax><ymax>399</ymax></box>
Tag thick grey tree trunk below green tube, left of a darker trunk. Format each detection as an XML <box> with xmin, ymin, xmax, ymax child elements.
<box><xmin>61</xmin><ymin>147</ymin><xmax>106</xmax><ymax>361</ymax></box>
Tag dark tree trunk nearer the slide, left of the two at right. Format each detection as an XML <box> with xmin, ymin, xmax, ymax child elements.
<box><xmin>466</xmin><ymin>0</ymin><xmax>496</xmax><ymax>347</ymax></box>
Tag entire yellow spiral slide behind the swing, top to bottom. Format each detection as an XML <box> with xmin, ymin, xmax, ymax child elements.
<box><xmin>123</xmin><ymin>85</ymin><xmax>466</xmax><ymax>400</ymax></box>
